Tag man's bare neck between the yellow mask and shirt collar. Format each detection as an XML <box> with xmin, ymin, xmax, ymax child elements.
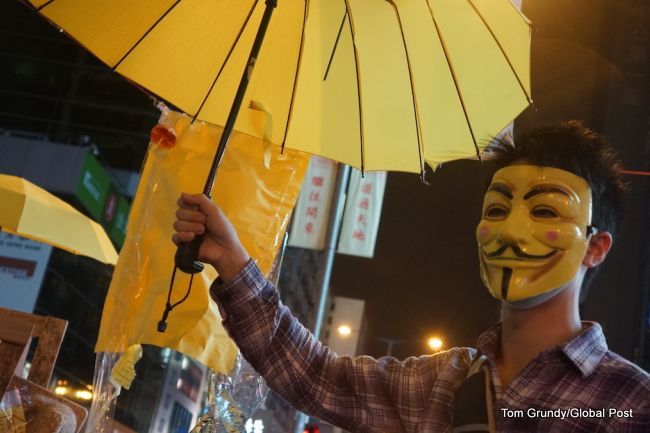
<box><xmin>497</xmin><ymin>284</ymin><xmax>582</xmax><ymax>389</ymax></box>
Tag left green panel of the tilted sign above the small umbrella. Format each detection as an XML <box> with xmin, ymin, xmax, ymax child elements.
<box><xmin>76</xmin><ymin>152</ymin><xmax>111</xmax><ymax>220</ymax></box>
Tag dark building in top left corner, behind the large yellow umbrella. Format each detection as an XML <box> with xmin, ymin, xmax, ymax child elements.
<box><xmin>0</xmin><ymin>1</ymin><xmax>158</xmax><ymax>171</ymax></box>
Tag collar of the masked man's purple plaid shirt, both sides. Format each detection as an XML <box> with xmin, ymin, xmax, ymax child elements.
<box><xmin>476</xmin><ymin>322</ymin><xmax>607</xmax><ymax>377</ymax></box>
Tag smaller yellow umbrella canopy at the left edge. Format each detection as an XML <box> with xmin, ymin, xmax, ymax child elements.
<box><xmin>0</xmin><ymin>174</ymin><xmax>117</xmax><ymax>265</ymax></box>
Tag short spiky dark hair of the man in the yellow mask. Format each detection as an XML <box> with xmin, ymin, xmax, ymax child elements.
<box><xmin>488</xmin><ymin>120</ymin><xmax>627</xmax><ymax>302</ymax></box>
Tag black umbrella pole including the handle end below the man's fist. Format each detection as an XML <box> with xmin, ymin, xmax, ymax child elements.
<box><xmin>174</xmin><ymin>0</ymin><xmax>278</xmax><ymax>274</ymax></box>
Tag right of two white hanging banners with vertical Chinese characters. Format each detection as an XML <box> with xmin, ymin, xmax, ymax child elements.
<box><xmin>337</xmin><ymin>168</ymin><xmax>386</xmax><ymax>258</ymax></box>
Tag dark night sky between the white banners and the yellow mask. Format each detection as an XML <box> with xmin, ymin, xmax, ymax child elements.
<box><xmin>332</xmin><ymin>161</ymin><xmax>498</xmax><ymax>356</ymax></box>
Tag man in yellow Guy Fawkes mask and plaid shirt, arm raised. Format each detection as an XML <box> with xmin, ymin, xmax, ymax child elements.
<box><xmin>173</xmin><ymin>122</ymin><xmax>650</xmax><ymax>433</ymax></box>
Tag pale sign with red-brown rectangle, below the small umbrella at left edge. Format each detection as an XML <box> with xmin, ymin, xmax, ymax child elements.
<box><xmin>0</xmin><ymin>232</ymin><xmax>52</xmax><ymax>313</ymax></box>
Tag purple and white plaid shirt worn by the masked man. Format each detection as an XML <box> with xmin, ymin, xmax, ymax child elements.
<box><xmin>211</xmin><ymin>261</ymin><xmax>650</xmax><ymax>433</ymax></box>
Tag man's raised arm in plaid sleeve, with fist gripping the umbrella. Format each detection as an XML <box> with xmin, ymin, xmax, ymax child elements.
<box><xmin>173</xmin><ymin>194</ymin><xmax>460</xmax><ymax>432</ymax></box>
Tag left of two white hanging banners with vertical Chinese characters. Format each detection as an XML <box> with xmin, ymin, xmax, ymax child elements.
<box><xmin>289</xmin><ymin>156</ymin><xmax>336</xmax><ymax>250</ymax></box>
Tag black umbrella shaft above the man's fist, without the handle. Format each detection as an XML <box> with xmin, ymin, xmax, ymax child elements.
<box><xmin>203</xmin><ymin>0</ymin><xmax>278</xmax><ymax>197</ymax></box>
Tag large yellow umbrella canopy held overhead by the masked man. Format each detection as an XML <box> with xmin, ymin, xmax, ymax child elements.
<box><xmin>29</xmin><ymin>0</ymin><xmax>530</xmax><ymax>176</ymax></box>
